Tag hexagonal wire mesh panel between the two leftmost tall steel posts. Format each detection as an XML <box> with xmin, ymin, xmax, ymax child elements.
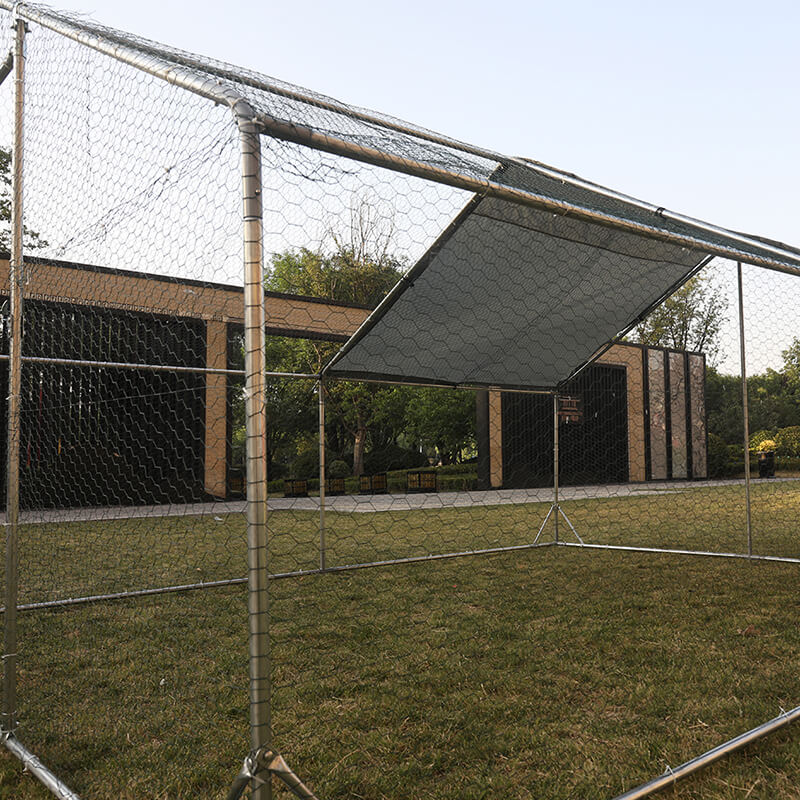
<box><xmin>0</xmin><ymin>4</ymin><xmax>256</xmax><ymax>797</ymax></box>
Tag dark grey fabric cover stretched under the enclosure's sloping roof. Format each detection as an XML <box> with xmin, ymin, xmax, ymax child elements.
<box><xmin>327</xmin><ymin>166</ymin><xmax>800</xmax><ymax>389</ymax></box>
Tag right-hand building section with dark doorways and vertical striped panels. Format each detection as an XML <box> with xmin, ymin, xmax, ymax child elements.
<box><xmin>477</xmin><ymin>344</ymin><xmax>708</xmax><ymax>488</ymax></box>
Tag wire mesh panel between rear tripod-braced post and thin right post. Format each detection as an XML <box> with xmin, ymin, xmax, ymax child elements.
<box><xmin>544</xmin><ymin>261</ymin><xmax>747</xmax><ymax>554</ymax></box>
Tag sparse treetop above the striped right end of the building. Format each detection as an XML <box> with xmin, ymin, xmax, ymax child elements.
<box><xmin>630</xmin><ymin>273</ymin><xmax>728</xmax><ymax>365</ymax></box>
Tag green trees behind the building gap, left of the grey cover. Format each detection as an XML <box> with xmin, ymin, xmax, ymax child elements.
<box><xmin>256</xmin><ymin>211</ymin><xmax>475</xmax><ymax>477</ymax></box>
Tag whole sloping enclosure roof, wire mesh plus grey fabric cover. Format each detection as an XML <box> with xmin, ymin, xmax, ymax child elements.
<box><xmin>15</xmin><ymin>0</ymin><xmax>800</xmax><ymax>389</ymax></box>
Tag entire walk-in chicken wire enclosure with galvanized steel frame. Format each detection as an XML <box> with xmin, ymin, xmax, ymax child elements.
<box><xmin>0</xmin><ymin>1</ymin><xmax>800</xmax><ymax>800</ymax></box>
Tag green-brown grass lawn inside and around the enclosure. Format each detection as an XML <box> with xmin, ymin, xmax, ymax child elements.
<box><xmin>0</xmin><ymin>483</ymin><xmax>800</xmax><ymax>800</ymax></box>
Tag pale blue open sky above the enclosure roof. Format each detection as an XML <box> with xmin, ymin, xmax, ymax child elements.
<box><xmin>70</xmin><ymin>0</ymin><xmax>800</xmax><ymax>245</ymax></box>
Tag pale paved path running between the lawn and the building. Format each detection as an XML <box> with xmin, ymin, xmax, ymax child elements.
<box><xmin>20</xmin><ymin>478</ymin><xmax>797</xmax><ymax>523</ymax></box>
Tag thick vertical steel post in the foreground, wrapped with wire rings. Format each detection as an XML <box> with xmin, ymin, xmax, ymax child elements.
<box><xmin>234</xmin><ymin>101</ymin><xmax>272</xmax><ymax>800</ymax></box>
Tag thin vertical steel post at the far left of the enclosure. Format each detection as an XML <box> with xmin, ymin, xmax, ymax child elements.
<box><xmin>3</xmin><ymin>19</ymin><xmax>25</xmax><ymax>733</ymax></box>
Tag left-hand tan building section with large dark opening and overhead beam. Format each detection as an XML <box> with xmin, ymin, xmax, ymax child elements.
<box><xmin>0</xmin><ymin>259</ymin><xmax>369</xmax><ymax>507</ymax></box>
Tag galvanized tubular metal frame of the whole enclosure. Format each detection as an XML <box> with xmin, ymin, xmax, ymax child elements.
<box><xmin>0</xmin><ymin>0</ymin><xmax>800</xmax><ymax>800</ymax></box>
